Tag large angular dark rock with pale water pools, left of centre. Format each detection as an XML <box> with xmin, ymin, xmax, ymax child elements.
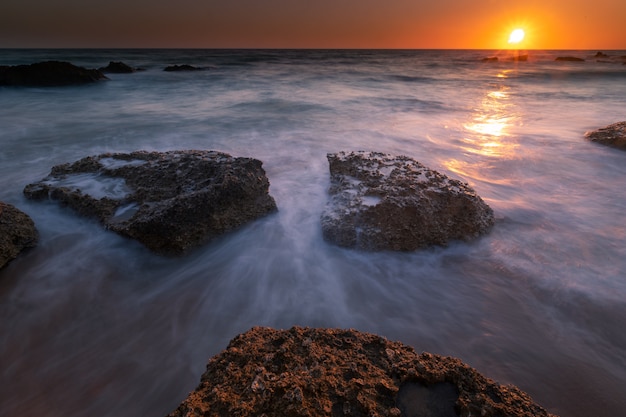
<box><xmin>24</xmin><ymin>151</ymin><xmax>276</xmax><ymax>255</ymax></box>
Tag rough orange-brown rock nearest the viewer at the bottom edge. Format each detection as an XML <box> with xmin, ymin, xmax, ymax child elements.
<box><xmin>169</xmin><ymin>327</ymin><xmax>550</xmax><ymax>417</ymax></box>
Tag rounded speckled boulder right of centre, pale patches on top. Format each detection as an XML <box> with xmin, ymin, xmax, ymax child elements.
<box><xmin>321</xmin><ymin>152</ymin><xmax>494</xmax><ymax>251</ymax></box>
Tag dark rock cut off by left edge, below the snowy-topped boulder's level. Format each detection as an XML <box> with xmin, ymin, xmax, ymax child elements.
<box><xmin>0</xmin><ymin>201</ymin><xmax>39</xmax><ymax>268</ymax></box>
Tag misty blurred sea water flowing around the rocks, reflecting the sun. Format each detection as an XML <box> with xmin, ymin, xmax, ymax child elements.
<box><xmin>0</xmin><ymin>50</ymin><xmax>626</xmax><ymax>417</ymax></box>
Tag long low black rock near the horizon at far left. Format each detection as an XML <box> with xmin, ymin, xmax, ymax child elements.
<box><xmin>0</xmin><ymin>61</ymin><xmax>107</xmax><ymax>87</ymax></box>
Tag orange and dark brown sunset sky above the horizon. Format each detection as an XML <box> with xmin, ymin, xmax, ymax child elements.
<box><xmin>0</xmin><ymin>0</ymin><xmax>626</xmax><ymax>50</ymax></box>
